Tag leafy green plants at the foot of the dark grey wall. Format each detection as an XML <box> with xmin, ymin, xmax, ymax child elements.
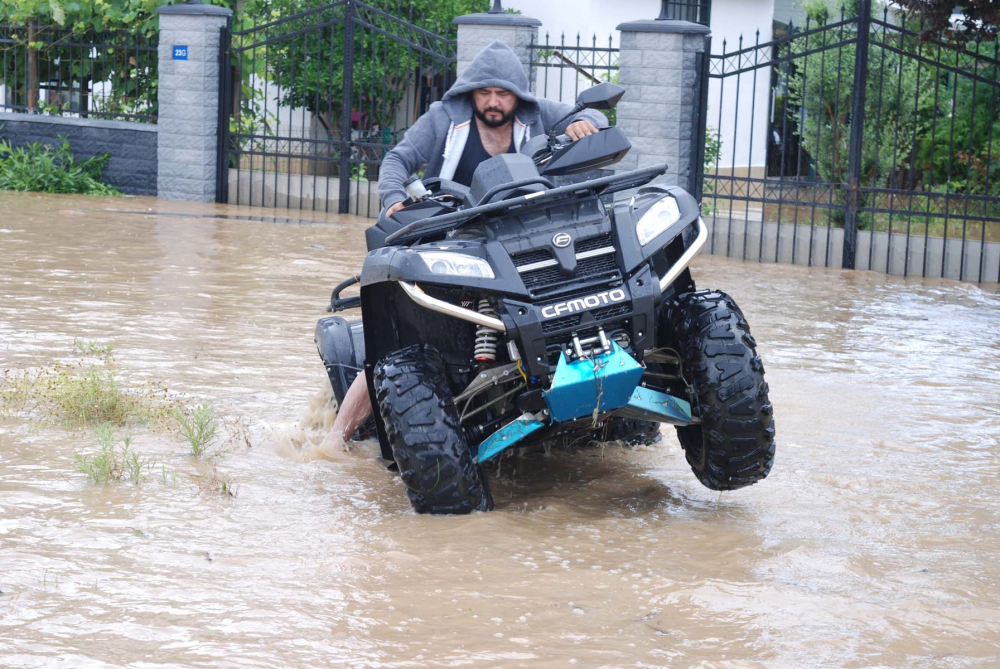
<box><xmin>0</xmin><ymin>136</ymin><xmax>120</xmax><ymax>195</ymax></box>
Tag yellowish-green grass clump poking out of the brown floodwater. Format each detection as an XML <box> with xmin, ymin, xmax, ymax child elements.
<box><xmin>0</xmin><ymin>342</ymin><xmax>176</xmax><ymax>427</ymax></box>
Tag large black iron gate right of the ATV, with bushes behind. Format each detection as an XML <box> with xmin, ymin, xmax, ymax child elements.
<box><xmin>703</xmin><ymin>0</ymin><xmax>1000</xmax><ymax>282</ymax></box>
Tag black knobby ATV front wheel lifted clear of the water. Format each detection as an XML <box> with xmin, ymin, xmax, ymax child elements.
<box><xmin>664</xmin><ymin>290</ymin><xmax>775</xmax><ymax>490</ymax></box>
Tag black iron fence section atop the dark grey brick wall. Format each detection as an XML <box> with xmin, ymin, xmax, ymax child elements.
<box><xmin>0</xmin><ymin>24</ymin><xmax>157</xmax><ymax>123</ymax></box>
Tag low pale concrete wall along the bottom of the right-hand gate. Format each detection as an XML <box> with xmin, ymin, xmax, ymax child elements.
<box><xmin>703</xmin><ymin>213</ymin><xmax>1000</xmax><ymax>283</ymax></box>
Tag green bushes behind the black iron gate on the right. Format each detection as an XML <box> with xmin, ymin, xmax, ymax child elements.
<box><xmin>781</xmin><ymin>0</ymin><xmax>1000</xmax><ymax>227</ymax></box>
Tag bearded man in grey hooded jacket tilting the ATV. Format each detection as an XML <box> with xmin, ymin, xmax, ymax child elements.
<box><xmin>333</xmin><ymin>40</ymin><xmax>608</xmax><ymax>441</ymax></box>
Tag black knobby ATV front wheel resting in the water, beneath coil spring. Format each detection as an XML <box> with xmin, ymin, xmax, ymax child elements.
<box><xmin>375</xmin><ymin>345</ymin><xmax>493</xmax><ymax>514</ymax></box>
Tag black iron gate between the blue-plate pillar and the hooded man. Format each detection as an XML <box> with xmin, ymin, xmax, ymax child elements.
<box><xmin>217</xmin><ymin>0</ymin><xmax>457</xmax><ymax>217</ymax></box>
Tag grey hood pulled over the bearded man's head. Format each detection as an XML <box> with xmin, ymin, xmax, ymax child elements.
<box><xmin>441</xmin><ymin>40</ymin><xmax>539</xmax><ymax>121</ymax></box>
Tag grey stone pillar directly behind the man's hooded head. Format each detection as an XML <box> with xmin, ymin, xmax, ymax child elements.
<box><xmin>455</xmin><ymin>0</ymin><xmax>542</xmax><ymax>80</ymax></box>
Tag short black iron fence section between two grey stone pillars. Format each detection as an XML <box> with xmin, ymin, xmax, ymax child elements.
<box><xmin>528</xmin><ymin>33</ymin><xmax>618</xmax><ymax>103</ymax></box>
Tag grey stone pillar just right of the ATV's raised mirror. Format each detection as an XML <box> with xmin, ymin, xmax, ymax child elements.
<box><xmin>615</xmin><ymin>11</ymin><xmax>709</xmax><ymax>193</ymax></box>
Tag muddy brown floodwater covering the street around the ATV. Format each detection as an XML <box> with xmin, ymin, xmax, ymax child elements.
<box><xmin>0</xmin><ymin>189</ymin><xmax>1000</xmax><ymax>669</ymax></box>
